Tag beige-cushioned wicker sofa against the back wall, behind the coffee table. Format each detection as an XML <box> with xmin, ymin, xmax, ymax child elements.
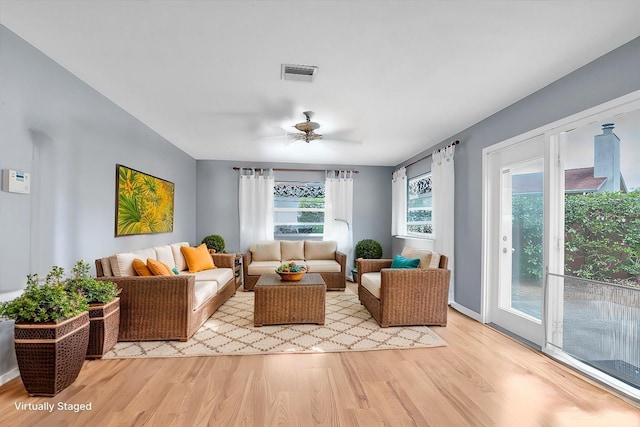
<box><xmin>242</xmin><ymin>240</ymin><xmax>347</xmax><ymax>291</ymax></box>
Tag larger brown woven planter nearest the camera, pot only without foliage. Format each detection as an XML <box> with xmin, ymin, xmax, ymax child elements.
<box><xmin>14</xmin><ymin>311</ymin><xmax>89</xmax><ymax>397</ymax></box>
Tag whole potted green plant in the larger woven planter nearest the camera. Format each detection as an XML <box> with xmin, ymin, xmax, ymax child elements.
<box><xmin>0</xmin><ymin>266</ymin><xmax>89</xmax><ymax>396</ymax></box>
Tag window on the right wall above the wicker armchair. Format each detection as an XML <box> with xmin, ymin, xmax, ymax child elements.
<box><xmin>407</xmin><ymin>173</ymin><xmax>433</xmax><ymax>237</ymax></box>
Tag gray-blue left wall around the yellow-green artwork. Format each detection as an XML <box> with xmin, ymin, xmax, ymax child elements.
<box><xmin>0</xmin><ymin>26</ymin><xmax>196</xmax><ymax>384</ymax></box>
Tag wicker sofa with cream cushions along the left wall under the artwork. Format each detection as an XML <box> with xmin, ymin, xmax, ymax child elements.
<box><xmin>95</xmin><ymin>242</ymin><xmax>236</xmax><ymax>341</ymax></box>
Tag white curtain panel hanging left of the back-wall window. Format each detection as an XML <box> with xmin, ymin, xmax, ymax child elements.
<box><xmin>239</xmin><ymin>169</ymin><xmax>274</xmax><ymax>251</ymax></box>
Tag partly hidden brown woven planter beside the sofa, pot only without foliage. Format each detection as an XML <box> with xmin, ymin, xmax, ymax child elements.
<box><xmin>87</xmin><ymin>298</ymin><xmax>120</xmax><ymax>359</ymax></box>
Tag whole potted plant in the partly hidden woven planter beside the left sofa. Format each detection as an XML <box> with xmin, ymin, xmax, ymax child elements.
<box><xmin>66</xmin><ymin>260</ymin><xmax>120</xmax><ymax>359</ymax></box>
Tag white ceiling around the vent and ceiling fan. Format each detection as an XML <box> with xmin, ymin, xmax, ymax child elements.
<box><xmin>0</xmin><ymin>0</ymin><xmax>640</xmax><ymax>166</ymax></box>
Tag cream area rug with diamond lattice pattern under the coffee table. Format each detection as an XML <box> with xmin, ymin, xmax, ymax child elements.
<box><xmin>103</xmin><ymin>289</ymin><xmax>447</xmax><ymax>359</ymax></box>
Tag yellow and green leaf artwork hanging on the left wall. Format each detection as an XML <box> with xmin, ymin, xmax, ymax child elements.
<box><xmin>116</xmin><ymin>165</ymin><xmax>174</xmax><ymax>237</ymax></box>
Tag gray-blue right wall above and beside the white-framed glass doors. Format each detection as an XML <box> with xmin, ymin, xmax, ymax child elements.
<box><xmin>399</xmin><ymin>38</ymin><xmax>640</xmax><ymax>313</ymax></box>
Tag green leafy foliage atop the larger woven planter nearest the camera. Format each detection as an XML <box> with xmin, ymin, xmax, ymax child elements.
<box><xmin>0</xmin><ymin>266</ymin><xmax>89</xmax><ymax>323</ymax></box>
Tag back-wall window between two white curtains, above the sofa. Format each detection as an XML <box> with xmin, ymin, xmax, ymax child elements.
<box><xmin>273</xmin><ymin>182</ymin><xmax>325</xmax><ymax>240</ymax></box>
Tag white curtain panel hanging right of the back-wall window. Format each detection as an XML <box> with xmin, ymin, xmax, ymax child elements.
<box><xmin>324</xmin><ymin>171</ymin><xmax>353</xmax><ymax>277</ymax></box>
